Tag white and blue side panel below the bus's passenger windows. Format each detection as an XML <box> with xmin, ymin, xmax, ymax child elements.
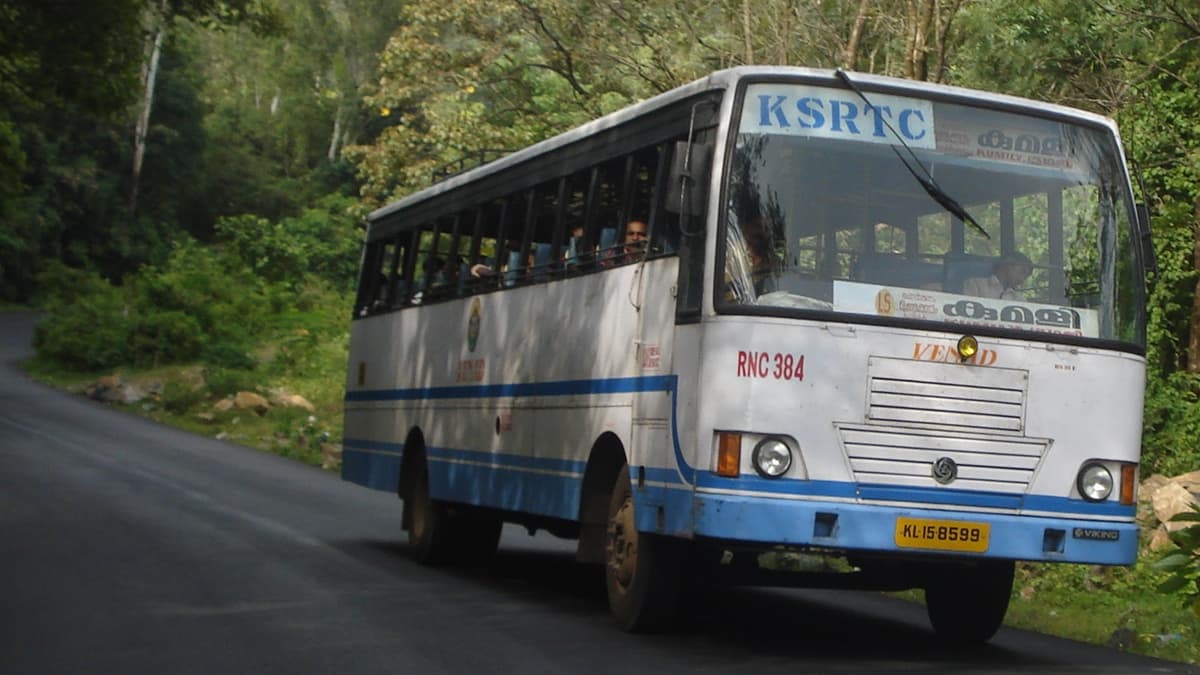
<box><xmin>343</xmin><ymin>259</ymin><xmax>676</xmax><ymax>519</ymax></box>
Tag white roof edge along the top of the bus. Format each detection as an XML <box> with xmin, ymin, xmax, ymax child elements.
<box><xmin>367</xmin><ymin>66</ymin><xmax>1120</xmax><ymax>222</ymax></box>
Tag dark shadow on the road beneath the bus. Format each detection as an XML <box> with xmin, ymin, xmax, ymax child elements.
<box><xmin>324</xmin><ymin>530</ymin><xmax>1075</xmax><ymax>673</ymax></box>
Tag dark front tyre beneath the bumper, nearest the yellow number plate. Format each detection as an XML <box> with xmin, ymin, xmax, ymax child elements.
<box><xmin>925</xmin><ymin>560</ymin><xmax>1013</xmax><ymax>645</ymax></box>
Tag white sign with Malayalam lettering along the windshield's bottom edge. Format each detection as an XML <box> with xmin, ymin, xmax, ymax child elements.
<box><xmin>833</xmin><ymin>281</ymin><xmax>1100</xmax><ymax>338</ymax></box>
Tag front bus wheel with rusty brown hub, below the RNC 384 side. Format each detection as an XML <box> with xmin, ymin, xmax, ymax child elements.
<box><xmin>605</xmin><ymin>465</ymin><xmax>680</xmax><ymax>632</ymax></box>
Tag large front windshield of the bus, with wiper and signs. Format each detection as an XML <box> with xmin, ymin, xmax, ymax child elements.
<box><xmin>716</xmin><ymin>83</ymin><xmax>1142</xmax><ymax>342</ymax></box>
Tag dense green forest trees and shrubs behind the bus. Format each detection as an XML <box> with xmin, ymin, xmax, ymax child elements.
<box><xmin>7</xmin><ymin>0</ymin><xmax>1200</xmax><ymax>661</ymax></box>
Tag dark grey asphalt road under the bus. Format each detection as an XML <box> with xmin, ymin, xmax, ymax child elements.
<box><xmin>0</xmin><ymin>313</ymin><xmax>1200</xmax><ymax>674</ymax></box>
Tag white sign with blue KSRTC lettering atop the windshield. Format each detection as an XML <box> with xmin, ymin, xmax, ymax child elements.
<box><xmin>740</xmin><ymin>84</ymin><xmax>937</xmax><ymax>149</ymax></box>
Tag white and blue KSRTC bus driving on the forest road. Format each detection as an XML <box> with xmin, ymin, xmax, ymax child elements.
<box><xmin>342</xmin><ymin>66</ymin><xmax>1153</xmax><ymax>644</ymax></box>
